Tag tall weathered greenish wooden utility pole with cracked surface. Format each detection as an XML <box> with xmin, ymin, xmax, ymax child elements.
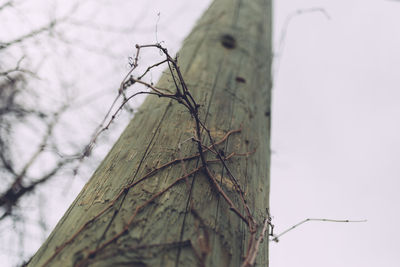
<box><xmin>28</xmin><ymin>0</ymin><xmax>272</xmax><ymax>266</ymax></box>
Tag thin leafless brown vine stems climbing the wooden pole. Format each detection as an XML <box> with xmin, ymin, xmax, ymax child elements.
<box><xmin>36</xmin><ymin>43</ymin><xmax>272</xmax><ymax>267</ymax></box>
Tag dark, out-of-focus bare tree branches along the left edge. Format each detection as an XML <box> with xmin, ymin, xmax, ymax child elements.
<box><xmin>0</xmin><ymin>1</ymin><xmax>84</xmax><ymax>220</ymax></box>
